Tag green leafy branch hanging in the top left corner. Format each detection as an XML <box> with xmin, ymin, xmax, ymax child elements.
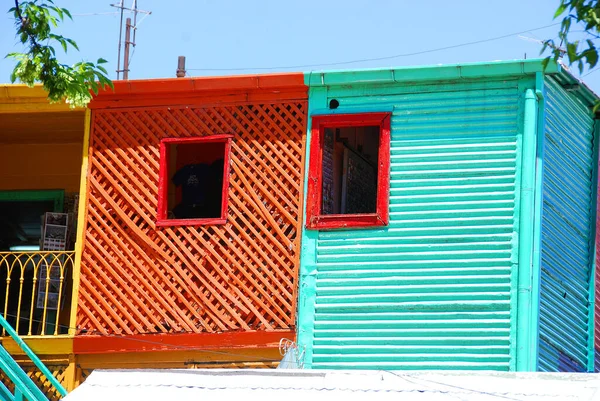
<box><xmin>6</xmin><ymin>0</ymin><xmax>113</xmax><ymax>107</ymax></box>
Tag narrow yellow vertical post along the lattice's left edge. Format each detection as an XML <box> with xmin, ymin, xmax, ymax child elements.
<box><xmin>69</xmin><ymin>109</ymin><xmax>92</xmax><ymax>335</ymax></box>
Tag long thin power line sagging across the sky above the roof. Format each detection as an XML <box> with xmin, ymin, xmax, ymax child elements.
<box><xmin>188</xmin><ymin>22</ymin><xmax>560</xmax><ymax>71</ymax></box>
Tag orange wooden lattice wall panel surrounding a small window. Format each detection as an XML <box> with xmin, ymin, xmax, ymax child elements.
<box><xmin>77</xmin><ymin>101</ymin><xmax>306</xmax><ymax>334</ymax></box>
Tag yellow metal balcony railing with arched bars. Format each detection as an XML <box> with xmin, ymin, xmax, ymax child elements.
<box><xmin>0</xmin><ymin>251</ymin><xmax>75</xmax><ymax>336</ymax></box>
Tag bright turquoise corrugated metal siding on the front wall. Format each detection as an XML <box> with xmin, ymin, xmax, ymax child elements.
<box><xmin>312</xmin><ymin>81</ymin><xmax>520</xmax><ymax>371</ymax></box>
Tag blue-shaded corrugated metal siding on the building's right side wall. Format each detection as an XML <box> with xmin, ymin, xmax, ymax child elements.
<box><xmin>539</xmin><ymin>79</ymin><xmax>594</xmax><ymax>371</ymax></box>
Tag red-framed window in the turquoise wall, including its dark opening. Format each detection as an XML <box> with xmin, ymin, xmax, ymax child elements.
<box><xmin>306</xmin><ymin>113</ymin><xmax>391</xmax><ymax>229</ymax></box>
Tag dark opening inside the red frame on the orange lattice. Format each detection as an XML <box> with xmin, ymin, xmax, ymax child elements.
<box><xmin>167</xmin><ymin>142</ymin><xmax>225</xmax><ymax>219</ymax></box>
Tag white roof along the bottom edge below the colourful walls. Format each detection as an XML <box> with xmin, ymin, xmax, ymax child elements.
<box><xmin>64</xmin><ymin>369</ymin><xmax>600</xmax><ymax>401</ymax></box>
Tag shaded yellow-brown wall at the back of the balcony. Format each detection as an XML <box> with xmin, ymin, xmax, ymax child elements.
<box><xmin>0</xmin><ymin>143</ymin><xmax>82</xmax><ymax>192</ymax></box>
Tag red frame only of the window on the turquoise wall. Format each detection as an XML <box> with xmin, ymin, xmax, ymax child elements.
<box><xmin>306</xmin><ymin>113</ymin><xmax>391</xmax><ymax>229</ymax></box>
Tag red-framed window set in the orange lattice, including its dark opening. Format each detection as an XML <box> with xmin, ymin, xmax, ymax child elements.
<box><xmin>156</xmin><ymin>135</ymin><xmax>233</xmax><ymax>226</ymax></box>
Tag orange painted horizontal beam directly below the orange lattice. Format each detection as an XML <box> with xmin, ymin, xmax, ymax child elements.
<box><xmin>73</xmin><ymin>331</ymin><xmax>296</xmax><ymax>354</ymax></box>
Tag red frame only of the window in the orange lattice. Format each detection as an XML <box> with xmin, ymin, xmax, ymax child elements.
<box><xmin>156</xmin><ymin>134</ymin><xmax>233</xmax><ymax>227</ymax></box>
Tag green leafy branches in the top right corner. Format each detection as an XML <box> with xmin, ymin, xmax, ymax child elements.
<box><xmin>542</xmin><ymin>0</ymin><xmax>600</xmax><ymax>73</ymax></box>
